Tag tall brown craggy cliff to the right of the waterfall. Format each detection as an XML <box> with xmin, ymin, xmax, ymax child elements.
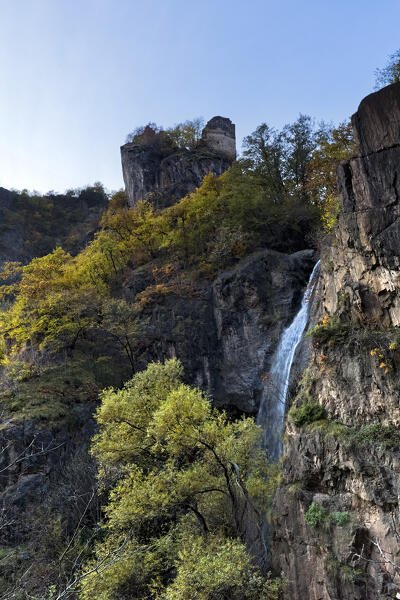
<box><xmin>271</xmin><ymin>84</ymin><xmax>400</xmax><ymax>600</ymax></box>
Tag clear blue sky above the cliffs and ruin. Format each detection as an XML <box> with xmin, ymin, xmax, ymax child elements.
<box><xmin>0</xmin><ymin>0</ymin><xmax>400</xmax><ymax>192</ymax></box>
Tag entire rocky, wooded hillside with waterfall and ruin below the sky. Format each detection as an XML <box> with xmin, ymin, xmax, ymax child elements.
<box><xmin>0</xmin><ymin>91</ymin><xmax>400</xmax><ymax>600</ymax></box>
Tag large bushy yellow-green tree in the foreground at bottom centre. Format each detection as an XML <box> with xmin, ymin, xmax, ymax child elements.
<box><xmin>81</xmin><ymin>359</ymin><xmax>279</xmax><ymax>600</ymax></box>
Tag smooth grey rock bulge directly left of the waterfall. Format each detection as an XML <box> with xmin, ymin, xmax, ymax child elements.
<box><xmin>213</xmin><ymin>250</ymin><xmax>316</xmax><ymax>414</ymax></box>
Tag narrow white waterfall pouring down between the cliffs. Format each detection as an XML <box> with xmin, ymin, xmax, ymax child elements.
<box><xmin>257</xmin><ymin>261</ymin><xmax>319</xmax><ymax>461</ymax></box>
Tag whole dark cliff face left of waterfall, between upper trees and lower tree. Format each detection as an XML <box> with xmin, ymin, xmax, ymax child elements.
<box><xmin>120</xmin><ymin>250</ymin><xmax>316</xmax><ymax>414</ymax></box>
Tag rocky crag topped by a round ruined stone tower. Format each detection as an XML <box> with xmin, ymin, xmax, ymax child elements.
<box><xmin>121</xmin><ymin>117</ymin><xmax>236</xmax><ymax>209</ymax></box>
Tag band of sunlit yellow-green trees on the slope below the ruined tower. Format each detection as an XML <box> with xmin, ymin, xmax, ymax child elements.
<box><xmin>0</xmin><ymin>162</ymin><xmax>315</xmax><ymax>360</ymax></box>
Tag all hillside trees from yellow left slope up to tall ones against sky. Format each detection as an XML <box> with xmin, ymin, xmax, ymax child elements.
<box><xmin>0</xmin><ymin>116</ymin><xmax>352</xmax><ymax>366</ymax></box>
